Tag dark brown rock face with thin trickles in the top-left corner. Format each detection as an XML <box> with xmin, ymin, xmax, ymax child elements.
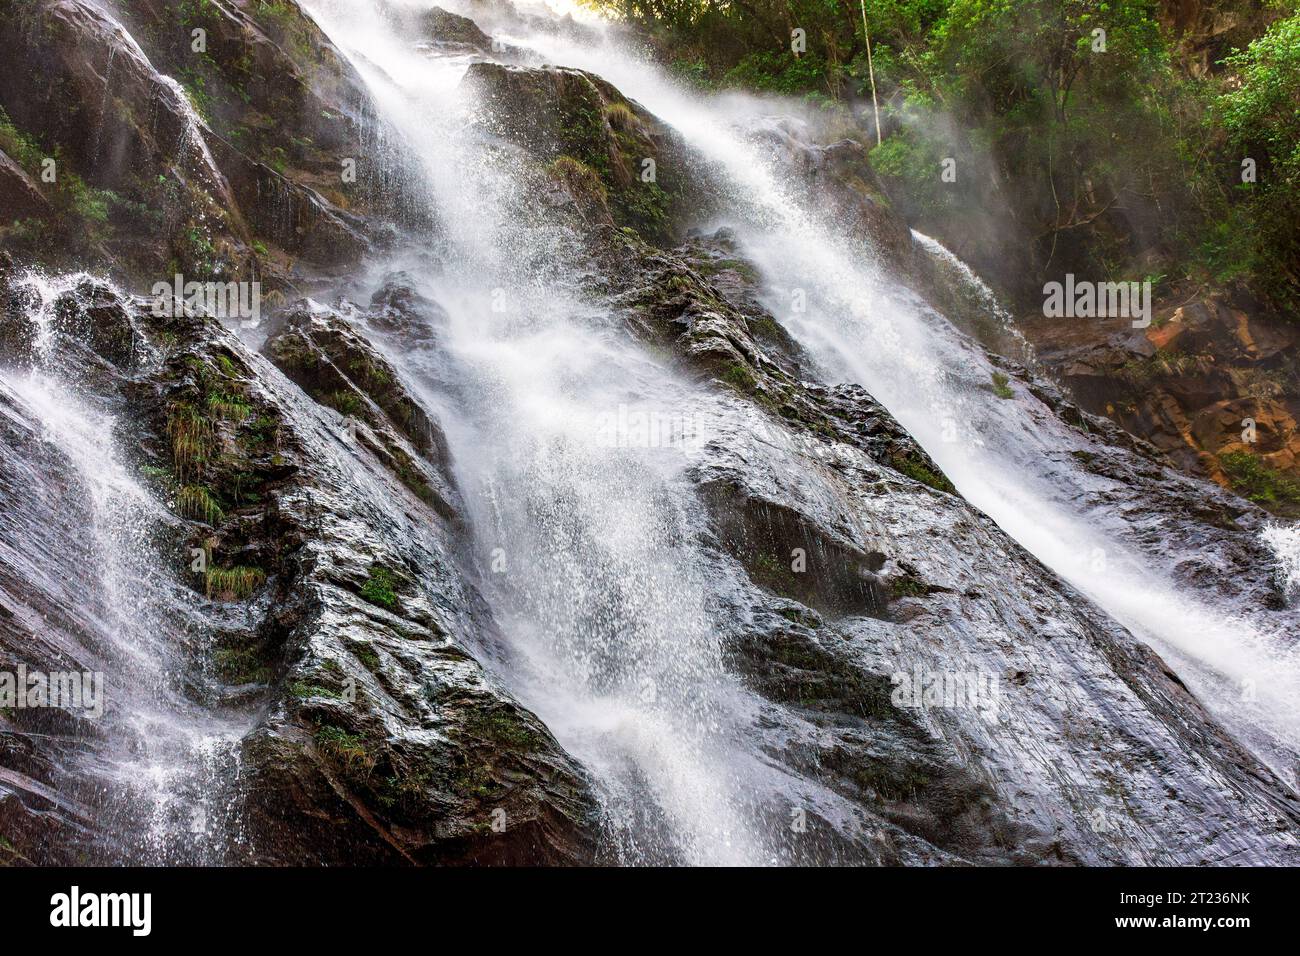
<box><xmin>0</xmin><ymin>0</ymin><xmax>377</xmax><ymax>282</ymax></box>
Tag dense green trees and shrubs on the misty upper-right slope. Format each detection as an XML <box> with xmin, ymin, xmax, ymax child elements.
<box><xmin>593</xmin><ymin>0</ymin><xmax>1300</xmax><ymax>308</ymax></box>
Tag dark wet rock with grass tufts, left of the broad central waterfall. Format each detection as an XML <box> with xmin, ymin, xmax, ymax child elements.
<box><xmin>0</xmin><ymin>270</ymin><xmax>598</xmax><ymax>864</ymax></box>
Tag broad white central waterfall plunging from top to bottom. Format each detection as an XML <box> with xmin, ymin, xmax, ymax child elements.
<box><xmin>307</xmin><ymin>0</ymin><xmax>811</xmax><ymax>865</ymax></box>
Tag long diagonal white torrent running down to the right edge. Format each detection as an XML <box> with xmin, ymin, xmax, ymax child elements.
<box><xmin>460</xmin><ymin>18</ymin><xmax>1300</xmax><ymax>780</ymax></box>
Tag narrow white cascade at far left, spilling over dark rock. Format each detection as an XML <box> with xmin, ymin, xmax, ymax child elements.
<box><xmin>0</xmin><ymin>274</ymin><xmax>246</xmax><ymax>864</ymax></box>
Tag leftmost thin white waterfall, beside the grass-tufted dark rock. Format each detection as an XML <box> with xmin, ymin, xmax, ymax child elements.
<box><xmin>0</xmin><ymin>274</ymin><xmax>247</xmax><ymax>864</ymax></box>
